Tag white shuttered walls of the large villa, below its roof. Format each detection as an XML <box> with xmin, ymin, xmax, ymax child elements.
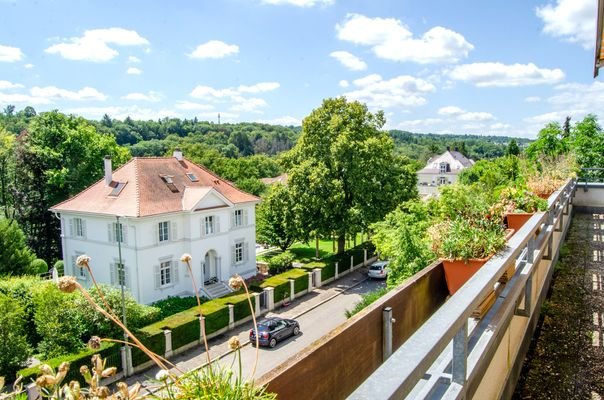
<box><xmin>59</xmin><ymin>200</ymin><xmax>256</xmax><ymax>304</ymax></box>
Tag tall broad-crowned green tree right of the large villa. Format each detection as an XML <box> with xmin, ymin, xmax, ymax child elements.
<box><xmin>286</xmin><ymin>97</ymin><xmax>417</xmax><ymax>252</ymax></box>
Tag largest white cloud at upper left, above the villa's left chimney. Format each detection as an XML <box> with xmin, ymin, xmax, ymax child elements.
<box><xmin>44</xmin><ymin>28</ymin><xmax>149</xmax><ymax>62</ymax></box>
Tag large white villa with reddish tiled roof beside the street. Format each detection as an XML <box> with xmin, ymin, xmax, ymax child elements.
<box><xmin>50</xmin><ymin>150</ymin><xmax>260</xmax><ymax>303</ymax></box>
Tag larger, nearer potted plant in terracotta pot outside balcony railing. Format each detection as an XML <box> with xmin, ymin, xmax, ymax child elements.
<box><xmin>429</xmin><ymin>217</ymin><xmax>506</xmax><ymax>295</ymax></box>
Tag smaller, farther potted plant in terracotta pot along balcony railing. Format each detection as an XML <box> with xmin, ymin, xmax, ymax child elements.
<box><xmin>491</xmin><ymin>187</ymin><xmax>547</xmax><ymax>232</ymax></box>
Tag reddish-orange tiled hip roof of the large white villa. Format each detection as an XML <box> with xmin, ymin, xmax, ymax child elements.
<box><xmin>50</xmin><ymin>157</ymin><xmax>260</xmax><ymax>217</ymax></box>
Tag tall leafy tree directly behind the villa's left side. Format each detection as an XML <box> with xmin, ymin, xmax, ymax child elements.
<box><xmin>12</xmin><ymin>111</ymin><xmax>129</xmax><ymax>262</ymax></box>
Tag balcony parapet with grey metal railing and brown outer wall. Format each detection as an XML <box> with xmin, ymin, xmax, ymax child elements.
<box><xmin>260</xmin><ymin>174</ymin><xmax>604</xmax><ymax>399</ymax></box>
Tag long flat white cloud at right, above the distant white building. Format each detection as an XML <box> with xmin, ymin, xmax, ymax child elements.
<box><xmin>449</xmin><ymin>62</ymin><xmax>564</xmax><ymax>87</ymax></box>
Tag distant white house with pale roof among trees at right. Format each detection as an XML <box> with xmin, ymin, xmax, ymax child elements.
<box><xmin>417</xmin><ymin>148</ymin><xmax>474</xmax><ymax>196</ymax></box>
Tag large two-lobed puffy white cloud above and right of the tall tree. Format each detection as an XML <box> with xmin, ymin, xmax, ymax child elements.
<box><xmin>336</xmin><ymin>14</ymin><xmax>474</xmax><ymax>64</ymax></box>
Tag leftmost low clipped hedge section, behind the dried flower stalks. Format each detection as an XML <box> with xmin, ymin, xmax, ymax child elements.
<box><xmin>18</xmin><ymin>342</ymin><xmax>122</xmax><ymax>386</ymax></box>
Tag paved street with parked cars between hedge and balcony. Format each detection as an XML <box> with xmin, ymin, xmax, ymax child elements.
<box><xmin>126</xmin><ymin>268</ymin><xmax>385</xmax><ymax>392</ymax></box>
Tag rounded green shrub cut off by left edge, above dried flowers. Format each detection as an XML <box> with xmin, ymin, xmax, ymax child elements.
<box><xmin>0</xmin><ymin>293</ymin><xmax>31</xmax><ymax>382</ymax></box>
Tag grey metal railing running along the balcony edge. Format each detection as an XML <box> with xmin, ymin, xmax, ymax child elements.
<box><xmin>349</xmin><ymin>180</ymin><xmax>576</xmax><ymax>400</ymax></box>
